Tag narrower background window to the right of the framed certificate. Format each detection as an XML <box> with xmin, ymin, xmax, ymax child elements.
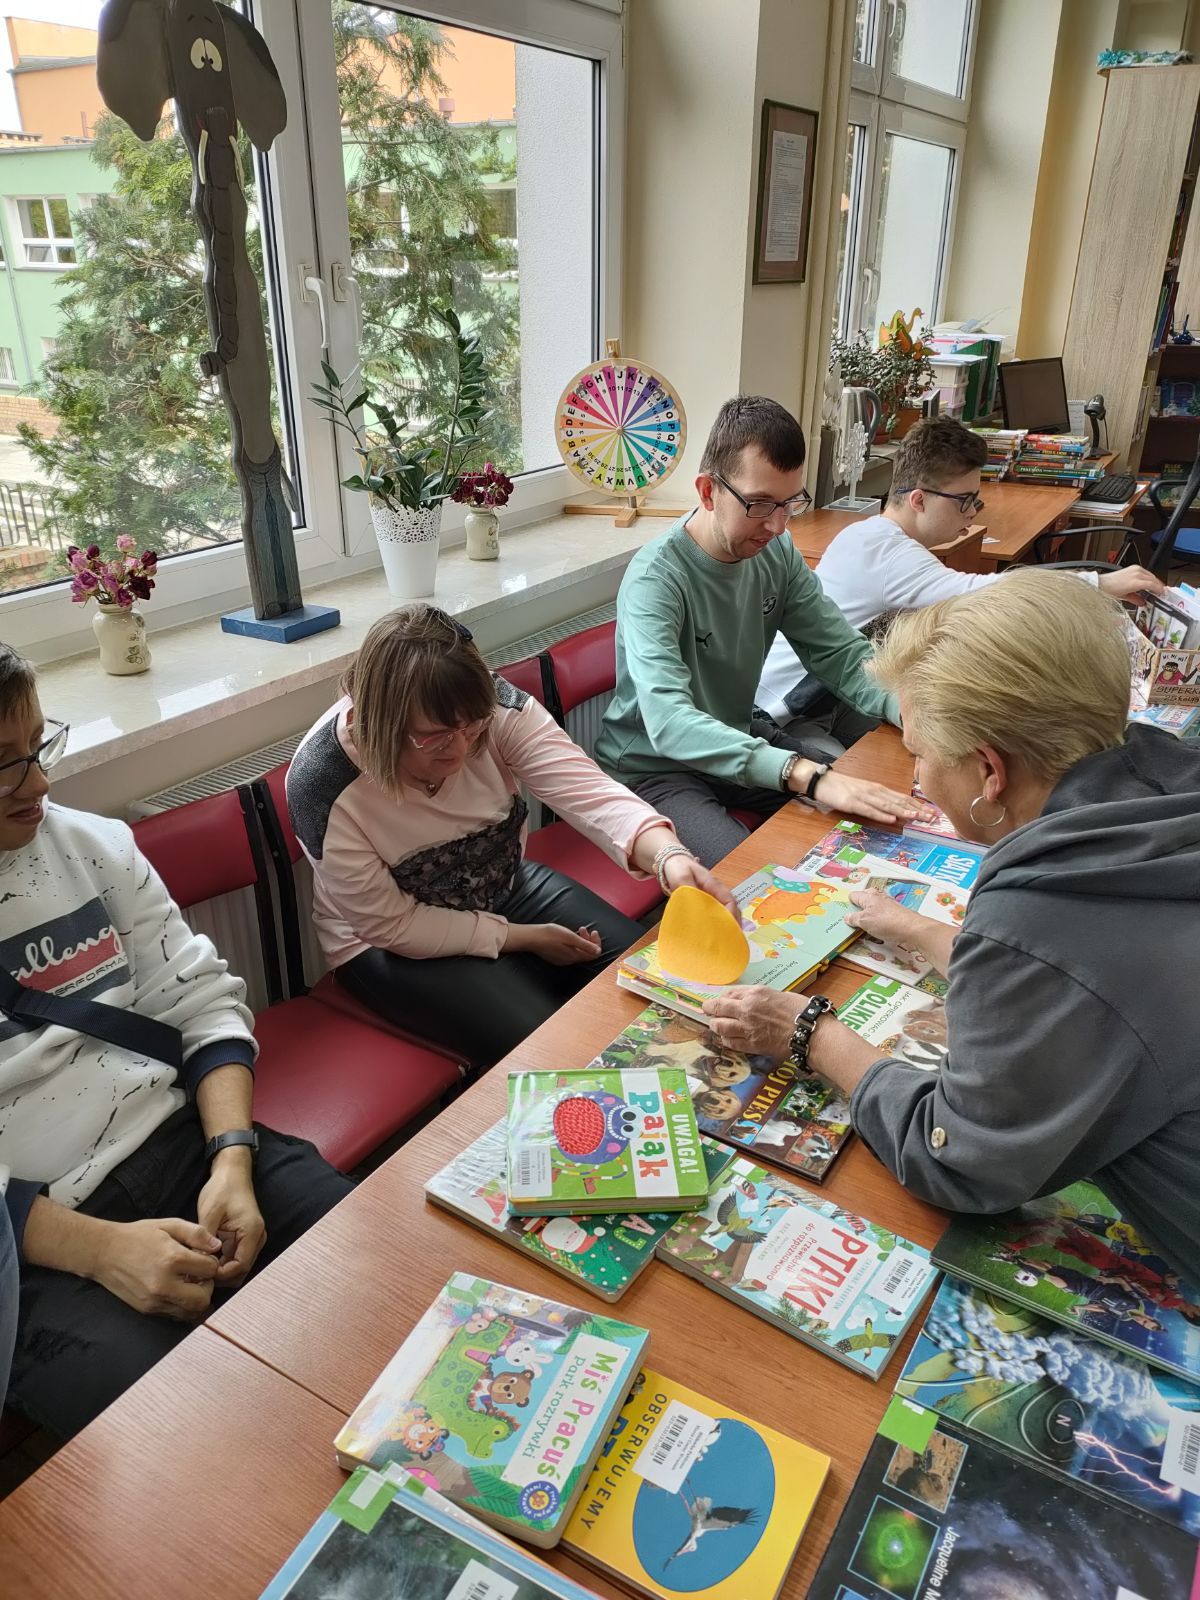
<box><xmin>835</xmin><ymin>0</ymin><xmax>976</xmax><ymax>334</ymax></box>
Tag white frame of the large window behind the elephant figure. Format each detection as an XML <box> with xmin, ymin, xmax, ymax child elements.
<box><xmin>0</xmin><ymin>0</ymin><xmax>624</xmax><ymax>661</ymax></box>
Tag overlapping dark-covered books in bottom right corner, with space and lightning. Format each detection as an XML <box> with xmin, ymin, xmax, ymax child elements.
<box><xmin>810</xmin><ymin>1184</ymin><xmax>1200</xmax><ymax>1600</ymax></box>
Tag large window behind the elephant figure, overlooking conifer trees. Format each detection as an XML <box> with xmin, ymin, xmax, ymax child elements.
<box><xmin>0</xmin><ymin>0</ymin><xmax>624</xmax><ymax>648</ymax></box>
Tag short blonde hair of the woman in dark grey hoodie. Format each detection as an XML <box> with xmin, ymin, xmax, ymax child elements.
<box><xmin>872</xmin><ymin>566</ymin><xmax>1131</xmax><ymax>782</ymax></box>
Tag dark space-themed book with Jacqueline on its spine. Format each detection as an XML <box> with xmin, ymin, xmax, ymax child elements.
<box><xmin>808</xmin><ymin>1398</ymin><xmax>1200</xmax><ymax>1600</ymax></box>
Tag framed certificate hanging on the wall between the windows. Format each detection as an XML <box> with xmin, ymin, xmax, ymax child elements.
<box><xmin>752</xmin><ymin>101</ymin><xmax>816</xmax><ymax>283</ymax></box>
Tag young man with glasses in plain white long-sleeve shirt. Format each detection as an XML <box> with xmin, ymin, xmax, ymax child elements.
<box><xmin>755</xmin><ymin>418</ymin><xmax>1163</xmax><ymax>732</ymax></box>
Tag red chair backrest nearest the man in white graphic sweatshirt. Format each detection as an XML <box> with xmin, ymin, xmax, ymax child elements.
<box><xmin>133</xmin><ymin>789</ymin><xmax>283</xmax><ymax>1005</ymax></box>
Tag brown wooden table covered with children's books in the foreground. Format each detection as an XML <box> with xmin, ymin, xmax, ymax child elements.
<box><xmin>0</xmin><ymin>728</ymin><xmax>942</xmax><ymax>1600</ymax></box>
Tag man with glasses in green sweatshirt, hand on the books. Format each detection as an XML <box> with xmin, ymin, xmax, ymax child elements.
<box><xmin>597</xmin><ymin>395</ymin><xmax>923</xmax><ymax>866</ymax></box>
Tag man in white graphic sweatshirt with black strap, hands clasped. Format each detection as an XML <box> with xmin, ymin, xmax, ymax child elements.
<box><xmin>0</xmin><ymin>645</ymin><xmax>350</xmax><ymax>1437</ymax></box>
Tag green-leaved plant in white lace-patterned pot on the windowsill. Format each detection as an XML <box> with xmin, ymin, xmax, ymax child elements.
<box><xmin>312</xmin><ymin>309</ymin><xmax>491</xmax><ymax>600</ymax></box>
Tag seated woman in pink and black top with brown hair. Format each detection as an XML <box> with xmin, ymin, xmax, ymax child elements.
<box><xmin>288</xmin><ymin>605</ymin><xmax>728</xmax><ymax>1064</ymax></box>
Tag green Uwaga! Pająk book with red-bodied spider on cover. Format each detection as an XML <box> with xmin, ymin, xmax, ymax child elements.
<box><xmin>507</xmin><ymin>1067</ymin><xmax>709</xmax><ymax>1216</ymax></box>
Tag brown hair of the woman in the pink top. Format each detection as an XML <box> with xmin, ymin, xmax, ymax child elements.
<box><xmin>342</xmin><ymin>602</ymin><xmax>496</xmax><ymax>792</ymax></box>
